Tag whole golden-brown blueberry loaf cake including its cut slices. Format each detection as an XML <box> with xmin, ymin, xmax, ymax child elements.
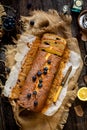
<box><xmin>18</xmin><ymin>34</ymin><xmax>66</xmax><ymax>112</ymax></box>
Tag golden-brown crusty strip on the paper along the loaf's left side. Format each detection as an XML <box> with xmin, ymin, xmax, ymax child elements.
<box><xmin>10</xmin><ymin>38</ymin><xmax>40</xmax><ymax>99</ymax></box>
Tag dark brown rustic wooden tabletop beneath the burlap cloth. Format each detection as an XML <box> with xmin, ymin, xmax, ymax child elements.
<box><xmin>0</xmin><ymin>0</ymin><xmax>87</xmax><ymax>130</ymax></box>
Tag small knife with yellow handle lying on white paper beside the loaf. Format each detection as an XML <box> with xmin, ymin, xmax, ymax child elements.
<box><xmin>53</xmin><ymin>66</ymin><xmax>72</xmax><ymax>103</ymax></box>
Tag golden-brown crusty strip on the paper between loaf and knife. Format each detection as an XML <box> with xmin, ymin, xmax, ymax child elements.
<box><xmin>42</xmin><ymin>48</ymin><xmax>70</xmax><ymax>113</ymax></box>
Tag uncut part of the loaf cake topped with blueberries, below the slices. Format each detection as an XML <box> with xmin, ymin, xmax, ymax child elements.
<box><xmin>19</xmin><ymin>51</ymin><xmax>61</xmax><ymax>111</ymax></box>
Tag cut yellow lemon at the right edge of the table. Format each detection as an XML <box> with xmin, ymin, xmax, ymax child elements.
<box><xmin>77</xmin><ymin>87</ymin><xmax>87</xmax><ymax>101</ymax></box>
